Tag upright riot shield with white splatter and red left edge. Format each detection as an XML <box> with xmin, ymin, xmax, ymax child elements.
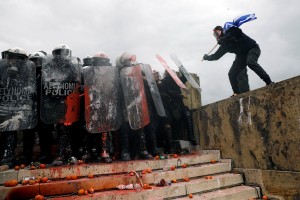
<box><xmin>83</xmin><ymin>66</ymin><xmax>122</xmax><ymax>133</ymax></box>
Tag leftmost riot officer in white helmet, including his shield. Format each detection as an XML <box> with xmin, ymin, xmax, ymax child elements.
<box><xmin>0</xmin><ymin>47</ymin><xmax>37</xmax><ymax>167</ymax></box>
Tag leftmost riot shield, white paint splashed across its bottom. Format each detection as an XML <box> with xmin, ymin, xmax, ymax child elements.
<box><xmin>0</xmin><ymin>59</ymin><xmax>37</xmax><ymax>132</ymax></box>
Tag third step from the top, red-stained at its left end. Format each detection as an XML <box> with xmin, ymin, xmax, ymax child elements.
<box><xmin>47</xmin><ymin>173</ymin><xmax>246</xmax><ymax>200</ymax></box>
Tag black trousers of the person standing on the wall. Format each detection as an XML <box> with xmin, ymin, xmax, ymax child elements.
<box><xmin>228</xmin><ymin>45</ymin><xmax>271</xmax><ymax>94</ymax></box>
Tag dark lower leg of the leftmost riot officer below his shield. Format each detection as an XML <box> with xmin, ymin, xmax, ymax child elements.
<box><xmin>1</xmin><ymin>132</ymin><xmax>17</xmax><ymax>167</ymax></box>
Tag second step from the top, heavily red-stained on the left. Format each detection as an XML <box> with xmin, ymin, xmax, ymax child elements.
<box><xmin>0</xmin><ymin>162</ymin><xmax>230</xmax><ymax>199</ymax></box>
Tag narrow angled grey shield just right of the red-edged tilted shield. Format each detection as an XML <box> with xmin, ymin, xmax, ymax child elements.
<box><xmin>141</xmin><ymin>64</ymin><xmax>166</xmax><ymax>117</ymax></box>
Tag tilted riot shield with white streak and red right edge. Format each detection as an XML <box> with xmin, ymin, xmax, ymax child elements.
<box><xmin>120</xmin><ymin>65</ymin><xmax>150</xmax><ymax>130</ymax></box>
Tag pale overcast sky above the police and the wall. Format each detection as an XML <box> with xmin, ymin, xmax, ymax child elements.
<box><xmin>0</xmin><ymin>0</ymin><xmax>300</xmax><ymax>105</ymax></box>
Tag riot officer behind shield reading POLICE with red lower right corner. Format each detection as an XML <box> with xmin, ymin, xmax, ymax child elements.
<box><xmin>41</xmin><ymin>44</ymin><xmax>81</xmax><ymax>165</ymax></box>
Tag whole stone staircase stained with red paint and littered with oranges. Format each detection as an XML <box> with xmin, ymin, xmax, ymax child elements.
<box><xmin>0</xmin><ymin>150</ymin><xmax>260</xmax><ymax>200</ymax></box>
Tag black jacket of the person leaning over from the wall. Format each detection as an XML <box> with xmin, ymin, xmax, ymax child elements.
<box><xmin>206</xmin><ymin>27</ymin><xmax>257</xmax><ymax>60</ymax></box>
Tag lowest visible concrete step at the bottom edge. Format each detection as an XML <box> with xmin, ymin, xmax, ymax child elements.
<box><xmin>177</xmin><ymin>185</ymin><xmax>260</xmax><ymax>200</ymax></box>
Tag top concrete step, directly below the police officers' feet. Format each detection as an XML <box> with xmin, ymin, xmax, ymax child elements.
<box><xmin>0</xmin><ymin>150</ymin><xmax>220</xmax><ymax>184</ymax></box>
